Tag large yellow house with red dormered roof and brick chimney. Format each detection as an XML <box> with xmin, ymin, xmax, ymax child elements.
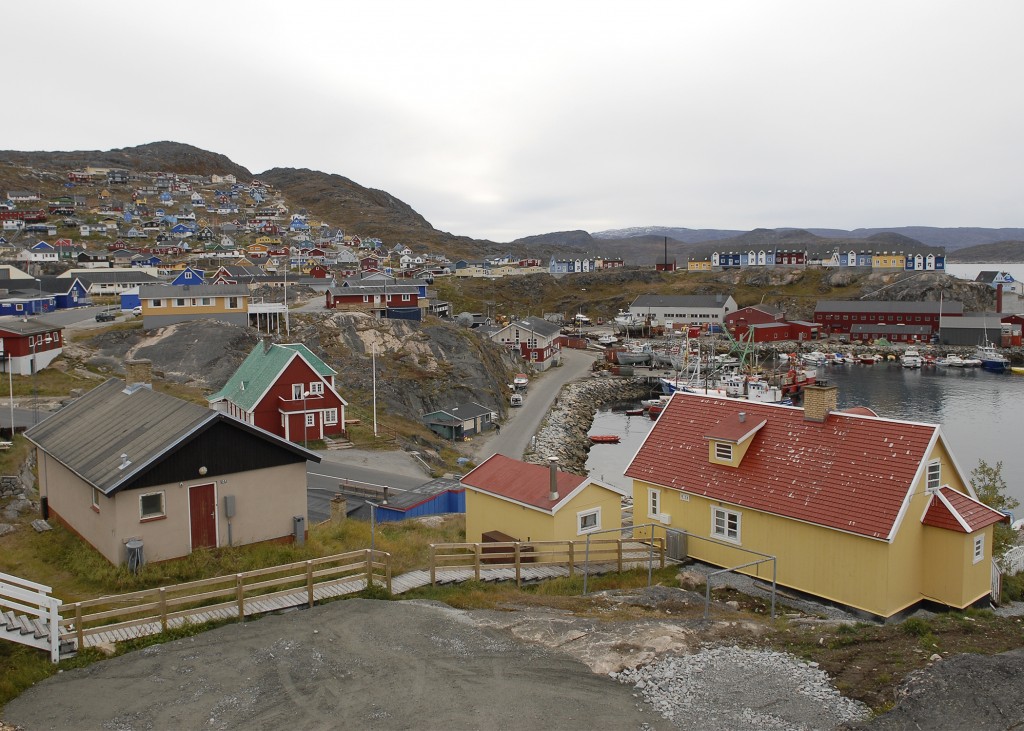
<box><xmin>626</xmin><ymin>387</ymin><xmax>1007</xmax><ymax>617</ymax></box>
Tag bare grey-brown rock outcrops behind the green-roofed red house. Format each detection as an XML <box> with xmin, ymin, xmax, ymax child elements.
<box><xmin>66</xmin><ymin>313</ymin><xmax>512</xmax><ymax>420</ymax></box>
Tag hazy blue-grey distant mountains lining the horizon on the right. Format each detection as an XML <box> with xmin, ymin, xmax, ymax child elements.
<box><xmin>593</xmin><ymin>226</ymin><xmax>1024</xmax><ymax>251</ymax></box>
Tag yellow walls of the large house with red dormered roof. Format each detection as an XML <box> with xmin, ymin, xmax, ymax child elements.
<box><xmin>634</xmin><ymin>432</ymin><xmax>991</xmax><ymax>616</ymax></box>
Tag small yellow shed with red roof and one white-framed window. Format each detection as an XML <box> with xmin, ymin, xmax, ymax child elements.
<box><xmin>461</xmin><ymin>455</ymin><xmax>624</xmax><ymax>543</ymax></box>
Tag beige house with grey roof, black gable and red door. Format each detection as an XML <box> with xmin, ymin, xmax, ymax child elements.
<box><xmin>26</xmin><ymin>361</ymin><xmax>319</xmax><ymax>564</ymax></box>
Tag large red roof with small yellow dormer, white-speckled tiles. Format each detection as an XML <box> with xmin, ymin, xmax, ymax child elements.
<box><xmin>626</xmin><ymin>392</ymin><xmax>938</xmax><ymax>540</ymax></box>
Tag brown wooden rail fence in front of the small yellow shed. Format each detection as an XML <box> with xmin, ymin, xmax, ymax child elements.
<box><xmin>430</xmin><ymin>538</ymin><xmax>665</xmax><ymax>586</ymax></box>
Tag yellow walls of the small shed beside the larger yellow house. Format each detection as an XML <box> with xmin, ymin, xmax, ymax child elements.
<box><xmin>466</xmin><ymin>484</ymin><xmax>623</xmax><ymax>543</ymax></box>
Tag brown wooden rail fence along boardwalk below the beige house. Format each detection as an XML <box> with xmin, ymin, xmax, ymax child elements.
<box><xmin>60</xmin><ymin>549</ymin><xmax>391</xmax><ymax>649</ymax></box>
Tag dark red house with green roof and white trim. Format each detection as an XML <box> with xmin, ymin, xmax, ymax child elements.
<box><xmin>208</xmin><ymin>339</ymin><xmax>348</xmax><ymax>443</ymax></box>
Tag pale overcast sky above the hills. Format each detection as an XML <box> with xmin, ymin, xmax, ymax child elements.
<box><xmin>0</xmin><ymin>0</ymin><xmax>1024</xmax><ymax>242</ymax></box>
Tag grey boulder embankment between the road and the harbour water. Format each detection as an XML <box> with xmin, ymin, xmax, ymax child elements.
<box><xmin>523</xmin><ymin>378</ymin><xmax>650</xmax><ymax>474</ymax></box>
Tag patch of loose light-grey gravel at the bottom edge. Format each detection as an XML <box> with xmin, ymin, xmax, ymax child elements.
<box><xmin>608</xmin><ymin>647</ymin><xmax>870</xmax><ymax>731</ymax></box>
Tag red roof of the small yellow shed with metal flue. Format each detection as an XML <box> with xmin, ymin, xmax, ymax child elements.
<box><xmin>460</xmin><ymin>455</ymin><xmax>592</xmax><ymax>511</ymax></box>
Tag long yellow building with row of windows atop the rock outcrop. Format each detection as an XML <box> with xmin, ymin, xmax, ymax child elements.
<box><xmin>138</xmin><ymin>285</ymin><xmax>252</xmax><ymax>330</ymax></box>
